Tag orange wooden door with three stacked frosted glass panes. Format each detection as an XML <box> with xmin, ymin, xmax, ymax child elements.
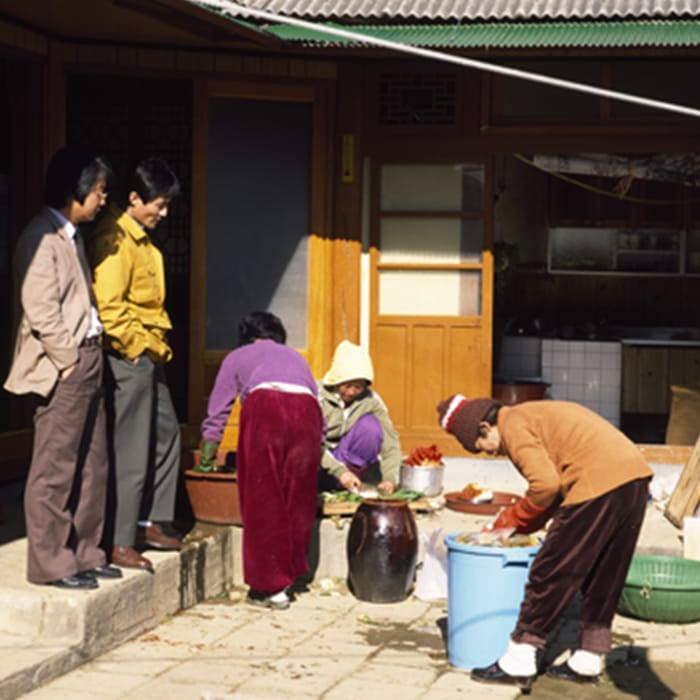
<box><xmin>370</xmin><ymin>163</ymin><xmax>493</xmax><ymax>454</ymax></box>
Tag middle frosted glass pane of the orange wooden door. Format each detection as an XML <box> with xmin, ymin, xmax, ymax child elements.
<box><xmin>379</xmin><ymin>217</ymin><xmax>483</xmax><ymax>264</ymax></box>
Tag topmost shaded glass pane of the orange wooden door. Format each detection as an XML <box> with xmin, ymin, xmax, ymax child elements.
<box><xmin>380</xmin><ymin>165</ymin><xmax>483</xmax><ymax>211</ymax></box>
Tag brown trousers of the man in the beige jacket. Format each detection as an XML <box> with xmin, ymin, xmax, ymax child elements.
<box><xmin>24</xmin><ymin>346</ymin><xmax>107</xmax><ymax>583</ymax></box>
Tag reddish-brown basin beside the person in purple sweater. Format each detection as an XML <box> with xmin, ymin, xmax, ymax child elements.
<box><xmin>185</xmin><ymin>450</ymin><xmax>242</xmax><ymax>525</ymax></box>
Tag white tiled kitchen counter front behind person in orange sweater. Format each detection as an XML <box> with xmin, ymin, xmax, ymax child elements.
<box><xmin>542</xmin><ymin>338</ymin><xmax>622</xmax><ymax>427</ymax></box>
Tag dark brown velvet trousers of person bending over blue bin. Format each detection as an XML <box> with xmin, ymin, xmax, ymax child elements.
<box><xmin>511</xmin><ymin>478</ymin><xmax>649</xmax><ymax>654</ymax></box>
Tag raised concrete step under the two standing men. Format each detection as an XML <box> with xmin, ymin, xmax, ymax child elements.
<box><xmin>0</xmin><ymin>527</ymin><xmax>240</xmax><ymax>700</ymax></box>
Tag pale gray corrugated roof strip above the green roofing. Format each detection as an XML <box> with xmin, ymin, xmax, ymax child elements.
<box><xmin>221</xmin><ymin>0</ymin><xmax>700</xmax><ymax>21</ymax></box>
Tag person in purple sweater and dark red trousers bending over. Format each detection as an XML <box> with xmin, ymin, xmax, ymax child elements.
<box><xmin>201</xmin><ymin>311</ymin><xmax>323</xmax><ymax>610</ymax></box>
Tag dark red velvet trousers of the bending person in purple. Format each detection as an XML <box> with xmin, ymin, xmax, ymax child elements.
<box><xmin>236</xmin><ymin>389</ymin><xmax>323</xmax><ymax>593</ymax></box>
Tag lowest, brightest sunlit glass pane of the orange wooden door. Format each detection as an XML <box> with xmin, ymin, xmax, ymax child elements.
<box><xmin>379</xmin><ymin>270</ymin><xmax>481</xmax><ymax>316</ymax></box>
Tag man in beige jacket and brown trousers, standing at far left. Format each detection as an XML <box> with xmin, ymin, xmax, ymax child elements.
<box><xmin>5</xmin><ymin>146</ymin><xmax>122</xmax><ymax>590</ymax></box>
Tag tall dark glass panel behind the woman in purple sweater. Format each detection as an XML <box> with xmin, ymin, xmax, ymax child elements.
<box><xmin>205</xmin><ymin>97</ymin><xmax>312</xmax><ymax>350</ymax></box>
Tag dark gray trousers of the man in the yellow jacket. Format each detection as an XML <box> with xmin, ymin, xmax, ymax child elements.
<box><xmin>107</xmin><ymin>355</ymin><xmax>180</xmax><ymax>547</ymax></box>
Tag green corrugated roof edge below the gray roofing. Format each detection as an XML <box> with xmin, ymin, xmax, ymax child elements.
<box><xmin>265</xmin><ymin>20</ymin><xmax>700</xmax><ymax>49</ymax></box>
